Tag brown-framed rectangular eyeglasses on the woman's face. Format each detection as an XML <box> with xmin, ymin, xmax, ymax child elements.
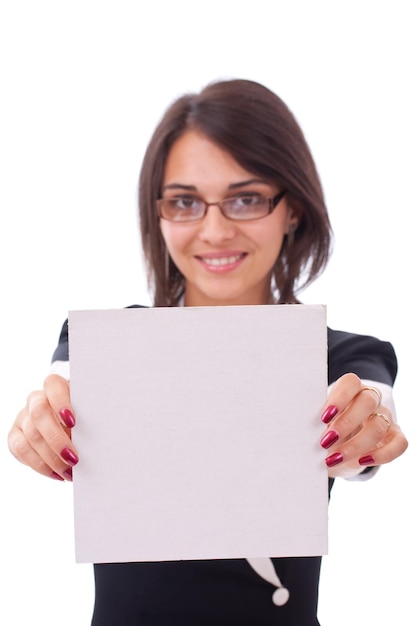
<box><xmin>156</xmin><ymin>189</ymin><xmax>287</xmax><ymax>222</ymax></box>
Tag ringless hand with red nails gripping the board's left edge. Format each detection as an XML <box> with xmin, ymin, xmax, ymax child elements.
<box><xmin>8</xmin><ymin>374</ymin><xmax>78</xmax><ymax>480</ymax></box>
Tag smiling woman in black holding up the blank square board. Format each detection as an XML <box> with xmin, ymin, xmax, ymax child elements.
<box><xmin>9</xmin><ymin>80</ymin><xmax>407</xmax><ymax>626</ymax></box>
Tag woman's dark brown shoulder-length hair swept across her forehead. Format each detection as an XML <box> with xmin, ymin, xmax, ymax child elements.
<box><xmin>139</xmin><ymin>80</ymin><xmax>332</xmax><ymax>306</ymax></box>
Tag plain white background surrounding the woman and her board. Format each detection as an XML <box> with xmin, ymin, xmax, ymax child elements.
<box><xmin>0</xmin><ymin>0</ymin><xmax>417</xmax><ymax>626</ymax></box>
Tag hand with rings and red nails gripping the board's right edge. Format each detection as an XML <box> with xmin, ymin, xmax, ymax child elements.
<box><xmin>320</xmin><ymin>374</ymin><xmax>408</xmax><ymax>478</ymax></box>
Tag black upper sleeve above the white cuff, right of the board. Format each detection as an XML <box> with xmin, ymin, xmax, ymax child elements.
<box><xmin>328</xmin><ymin>328</ymin><xmax>398</xmax><ymax>385</ymax></box>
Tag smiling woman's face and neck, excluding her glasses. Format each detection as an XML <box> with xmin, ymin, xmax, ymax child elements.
<box><xmin>160</xmin><ymin>130</ymin><xmax>297</xmax><ymax>306</ymax></box>
